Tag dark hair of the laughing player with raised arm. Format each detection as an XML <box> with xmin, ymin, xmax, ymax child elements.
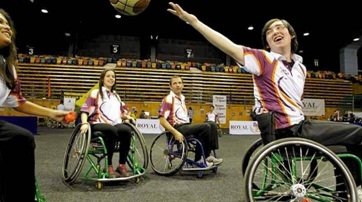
<box><xmin>261</xmin><ymin>18</ymin><xmax>298</xmax><ymax>53</ymax></box>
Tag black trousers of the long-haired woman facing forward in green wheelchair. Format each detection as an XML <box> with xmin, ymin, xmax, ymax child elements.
<box><xmin>91</xmin><ymin>123</ymin><xmax>132</xmax><ymax>165</ymax></box>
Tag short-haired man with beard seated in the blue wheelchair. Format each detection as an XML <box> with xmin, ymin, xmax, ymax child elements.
<box><xmin>159</xmin><ymin>76</ymin><xmax>223</xmax><ymax>166</ymax></box>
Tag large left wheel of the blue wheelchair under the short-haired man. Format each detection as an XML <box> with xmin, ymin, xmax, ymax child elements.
<box><xmin>150</xmin><ymin>132</ymin><xmax>187</xmax><ymax>176</ymax></box>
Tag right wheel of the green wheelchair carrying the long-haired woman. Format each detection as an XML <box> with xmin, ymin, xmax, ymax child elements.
<box><xmin>125</xmin><ymin>123</ymin><xmax>149</xmax><ymax>172</ymax></box>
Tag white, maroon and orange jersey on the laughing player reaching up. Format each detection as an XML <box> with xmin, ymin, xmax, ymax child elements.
<box><xmin>239</xmin><ymin>47</ymin><xmax>307</xmax><ymax>129</ymax></box>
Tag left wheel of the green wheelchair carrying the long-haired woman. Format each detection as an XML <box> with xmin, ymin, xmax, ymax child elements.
<box><xmin>62</xmin><ymin>124</ymin><xmax>91</xmax><ymax>184</ymax></box>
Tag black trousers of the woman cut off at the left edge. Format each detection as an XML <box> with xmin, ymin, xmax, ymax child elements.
<box><xmin>0</xmin><ymin>120</ymin><xmax>35</xmax><ymax>202</ymax></box>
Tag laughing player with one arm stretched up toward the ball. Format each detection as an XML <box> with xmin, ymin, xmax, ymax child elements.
<box><xmin>167</xmin><ymin>2</ymin><xmax>362</xmax><ymax>189</ymax></box>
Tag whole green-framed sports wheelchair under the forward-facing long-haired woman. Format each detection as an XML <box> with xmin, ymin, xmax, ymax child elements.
<box><xmin>63</xmin><ymin>123</ymin><xmax>149</xmax><ymax>189</ymax></box>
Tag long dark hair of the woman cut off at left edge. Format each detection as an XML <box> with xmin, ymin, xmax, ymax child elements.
<box><xmin>0</xmin><ymin>8</ymin><xmax>17</xmax><ymax>89</ymax></box>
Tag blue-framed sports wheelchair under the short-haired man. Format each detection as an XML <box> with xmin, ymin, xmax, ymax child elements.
<box><xmin>150</xmin><ymin>131</ymin><xmax>218</xmax><ymax>178</ymax></box>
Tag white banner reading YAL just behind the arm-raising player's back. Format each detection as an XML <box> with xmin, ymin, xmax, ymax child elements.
<box><xmin>302</xmin><ymin>99</ymin><xmax>326</xmax><ymax>116</ymax></box>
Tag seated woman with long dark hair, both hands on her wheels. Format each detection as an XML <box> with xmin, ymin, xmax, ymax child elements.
<box><xmin>80</xmin><ymin>69</ymin><xmax>134</xmax><ymax>177</ymax></box>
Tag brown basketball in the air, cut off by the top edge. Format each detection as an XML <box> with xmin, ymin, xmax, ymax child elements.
<box><xmin>109</xmin><ymin>0</ymin><xmax>151</xmax><ymax>16</ymax></box>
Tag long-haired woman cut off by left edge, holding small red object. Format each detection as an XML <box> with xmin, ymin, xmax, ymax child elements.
<box><xmin>0</xmin><ymin>9</ymin><xmax>69</xmax><ymax>202</ymax></box>
